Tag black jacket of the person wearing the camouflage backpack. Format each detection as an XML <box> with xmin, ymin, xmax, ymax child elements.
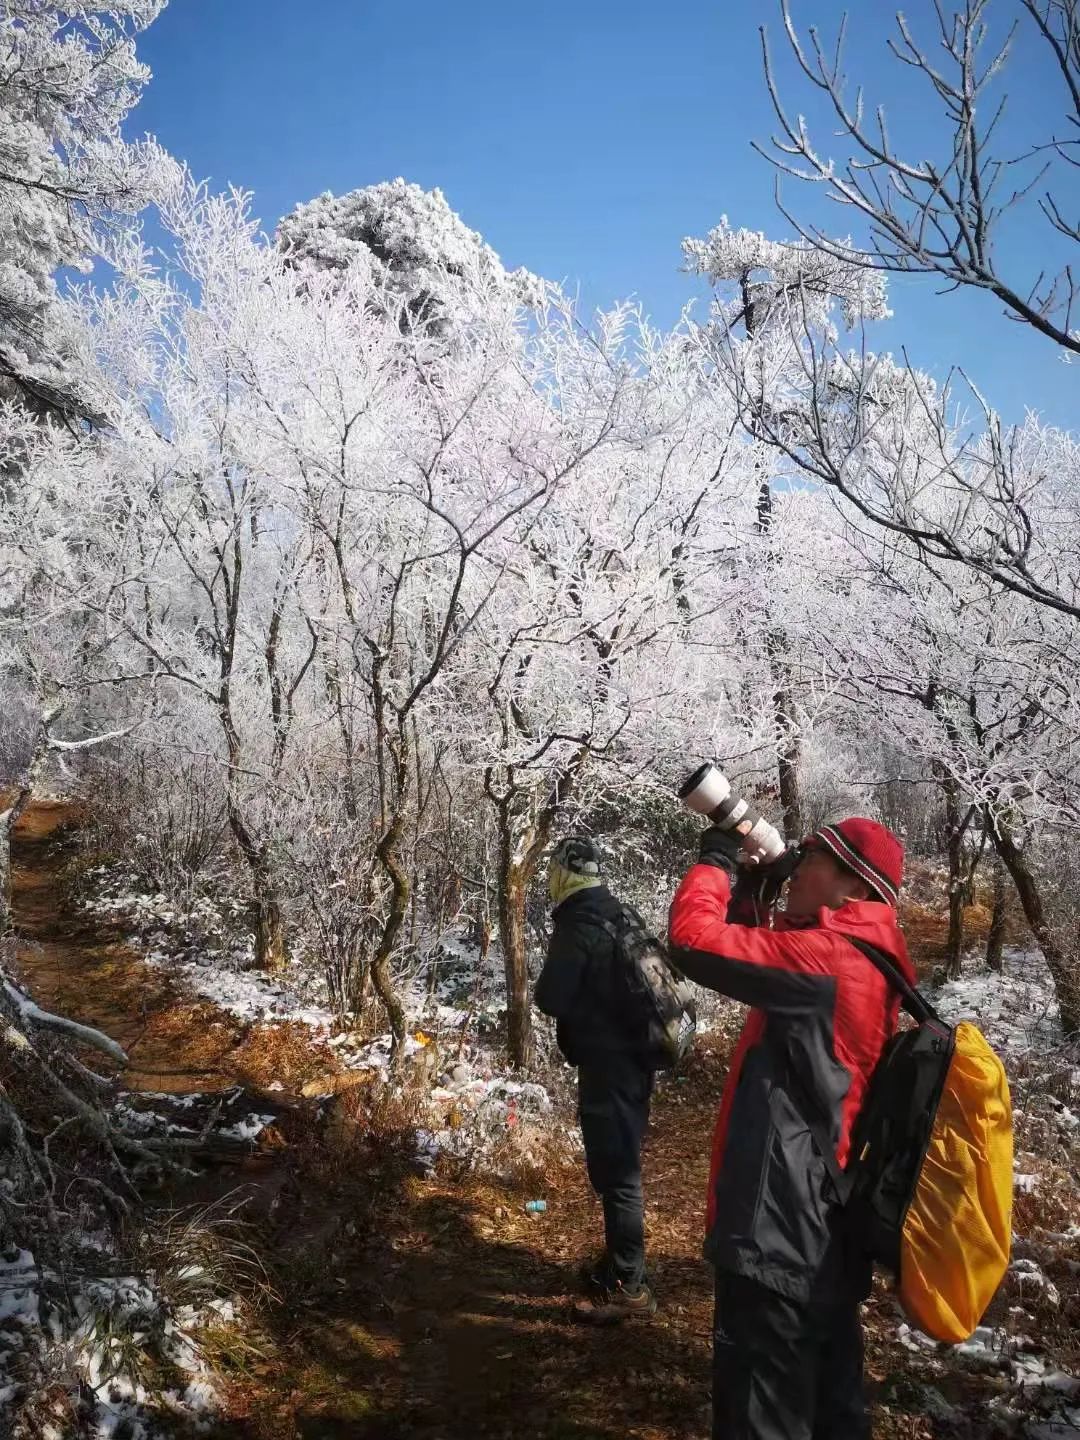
<box><xmin>533</xmin><ymin>886</ymin><xmax>638</xmax><ymax>1066</ymax></box>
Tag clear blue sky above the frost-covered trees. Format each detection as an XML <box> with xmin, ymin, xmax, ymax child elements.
<box><xmin>128</xmin><ymin>0</ymin><xmax>1080</xmax><ymax>425</ymax></box>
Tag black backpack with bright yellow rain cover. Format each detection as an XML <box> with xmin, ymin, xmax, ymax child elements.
<box><xmin>812</xmin><ymin>940</ymin><xmax>1012</xmax><ymax>1344</ymax></box>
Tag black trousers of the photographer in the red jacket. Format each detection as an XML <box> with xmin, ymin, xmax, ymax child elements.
<box><xmin>713</xmin><ymin>1272</ymin><xmax>870</xmax><ymax>1440</ymax></box>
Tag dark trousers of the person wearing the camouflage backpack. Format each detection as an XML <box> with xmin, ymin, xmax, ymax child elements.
<box><xmin>577</xmin><ymin>1051</ymin><xmax>652</xmax><ymax>1290</ymax></box>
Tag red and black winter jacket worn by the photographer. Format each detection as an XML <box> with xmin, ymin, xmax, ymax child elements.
<box><xmin>670</xmin><ymin>864</ymin><xmax>914</xmax><ymax>1300</ymax></box>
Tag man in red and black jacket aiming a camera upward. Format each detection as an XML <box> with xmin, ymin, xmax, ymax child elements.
<box><xmin>670</xmin><ymin>818</ymin><xmax>914</xmax><ymax>1440</ymax></box>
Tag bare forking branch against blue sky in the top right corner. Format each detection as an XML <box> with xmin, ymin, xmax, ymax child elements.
<box><xmin>756</xmin><ymin>0</ymin><xmax>1080</xmax><ymax>354</ymax></box>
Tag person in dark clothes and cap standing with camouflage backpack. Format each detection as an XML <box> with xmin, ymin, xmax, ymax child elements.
<box><xmin>534</xmin><ymin>838</ymin><xmax>657</xmax><ymax>1325</ymax></box>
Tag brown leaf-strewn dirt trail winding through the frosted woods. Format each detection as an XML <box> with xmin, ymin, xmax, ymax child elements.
<box><xmin>13</xmin><ymin>802</ymin><xmax>944</xmax><ymax>1440</ymax></box>
